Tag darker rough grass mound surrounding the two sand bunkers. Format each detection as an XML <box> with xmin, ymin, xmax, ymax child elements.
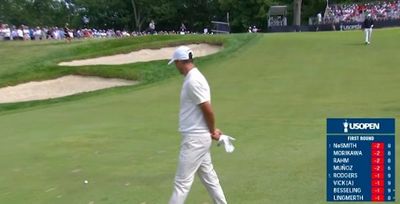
<box><xmin>0</xmin><ymin>35</ymin><xmax>254</xmax><ymax>112</ymax></box>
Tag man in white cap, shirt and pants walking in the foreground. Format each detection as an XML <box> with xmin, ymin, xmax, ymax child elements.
<box><xmin>168</xmin><ymin>46</ymin><xmax>227</xmax><ymax>204</ymax></box>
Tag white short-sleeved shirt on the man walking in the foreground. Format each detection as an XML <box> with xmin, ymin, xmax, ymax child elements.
<box><xmin>179</xmin><ymin>68</ymin><xmax>211</xmax><ymax>134</ymax></box>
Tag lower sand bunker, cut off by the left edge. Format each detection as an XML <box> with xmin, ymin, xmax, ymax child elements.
<box><xmin>0</xmin><ymin>75</ymin><xmax>137</xmax><ymax>103</ymax></box>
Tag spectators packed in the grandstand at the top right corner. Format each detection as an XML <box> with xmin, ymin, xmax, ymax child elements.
<box><xmin>323</xmin><ymin>0</ymin><xmax>400</xmax><ymax>23</ymax></box>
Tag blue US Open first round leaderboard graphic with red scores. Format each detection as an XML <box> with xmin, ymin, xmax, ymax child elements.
<box><xmin>326</xmin><ymin>118</ymin><xmax>396</xmax><ymax>202</ymax></box>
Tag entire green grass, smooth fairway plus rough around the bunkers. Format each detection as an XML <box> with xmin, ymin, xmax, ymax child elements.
<box><xmin>0</xmin><ymin>29</ymin><xmax>400</xmax><ymax>204</ymax></box>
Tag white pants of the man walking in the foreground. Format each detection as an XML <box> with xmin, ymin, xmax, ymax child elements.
<box><xmin>169</xmin><ymin>133</ymin><xmax>227</xmax><ymax>204</ymax></box>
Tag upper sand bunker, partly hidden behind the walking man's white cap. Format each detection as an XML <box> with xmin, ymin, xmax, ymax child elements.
<box><xmin>58</xmin><ymin>43</ymin><xmax>222</xmax><ymax>66</ymax></box>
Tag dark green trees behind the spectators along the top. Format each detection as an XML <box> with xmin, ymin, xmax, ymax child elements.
<box><xmin>0</xmin><ymin>0</ymin><xmax>357</xmax><ymax>32</ymax></box>
